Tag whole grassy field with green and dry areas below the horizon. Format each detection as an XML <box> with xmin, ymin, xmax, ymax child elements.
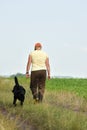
<box><xmin>0</xmin><ymin>77</ymin><xmax>87</xmax><ymax>130</ymax></box>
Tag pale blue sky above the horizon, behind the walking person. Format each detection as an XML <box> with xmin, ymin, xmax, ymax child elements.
<box><xmin>0</xmin><ymin>0</ymin><xmax>87</xmax><ymax>78</ymax></box>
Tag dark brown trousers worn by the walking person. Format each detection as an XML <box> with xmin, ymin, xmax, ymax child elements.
<box><xmin>30</xmin><ymin>70</ymin><xmax>46</xmax><ymax>101</ymax></box>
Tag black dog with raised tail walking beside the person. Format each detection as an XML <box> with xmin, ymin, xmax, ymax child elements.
<box><xmin>12</xmin><ymin>77</ymin><xmax>26</xmax><ymax>106</ymax></box>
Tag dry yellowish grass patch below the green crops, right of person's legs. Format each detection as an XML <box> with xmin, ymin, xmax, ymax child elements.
<box><xmin>44</xmin><ymin>91</ymin><xmax>87</xmax><ymax>112</ymax></box>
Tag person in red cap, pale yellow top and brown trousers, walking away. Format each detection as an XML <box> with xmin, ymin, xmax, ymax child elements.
<box><xmin>26</xmin><ymin>43</ymin><xmax>50</xmax><ymax>102</ymax></box>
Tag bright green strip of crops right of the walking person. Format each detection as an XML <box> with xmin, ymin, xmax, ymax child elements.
<box><xmin>47</xmin><ymin>78</ymin><xmax>87</xmax><ymax>99</ymax></box>
